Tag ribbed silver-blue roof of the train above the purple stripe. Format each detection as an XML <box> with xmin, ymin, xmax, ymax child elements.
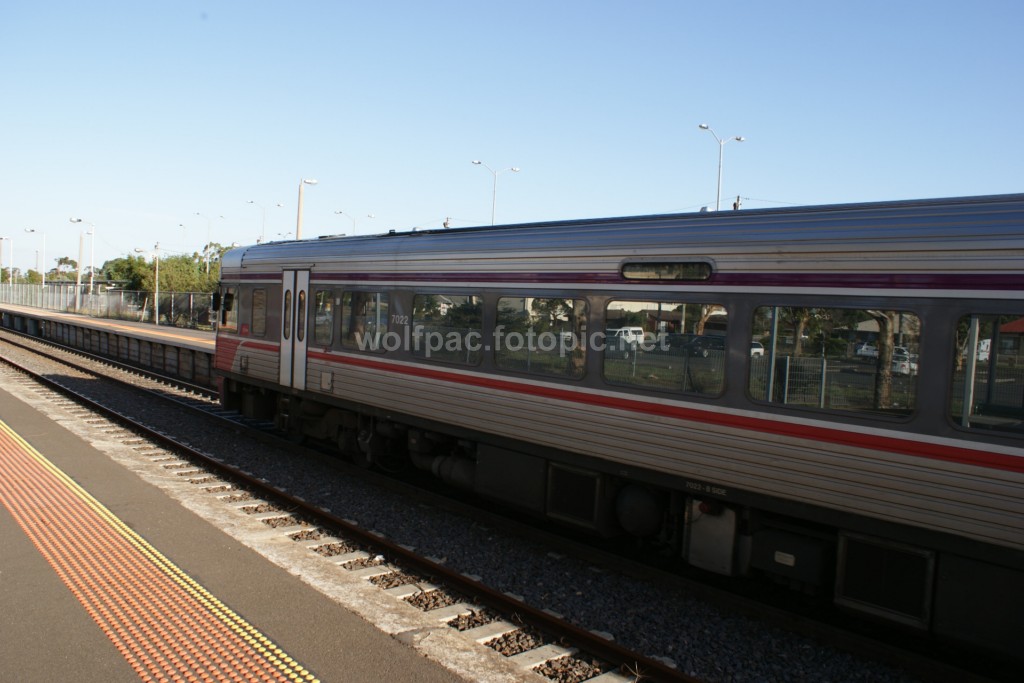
<box><xmin>221</xmin><ymin>194</ymin><xmax>1024</xmax><ymax>290</ymax></box>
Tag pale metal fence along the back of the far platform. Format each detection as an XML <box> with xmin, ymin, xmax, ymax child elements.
<box><xmin>0</xmin><ymin>283</ymin><xmax>213</xmax><ymax>330</ymax></box>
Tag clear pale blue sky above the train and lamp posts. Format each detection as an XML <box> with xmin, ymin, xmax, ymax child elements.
<box><xmin>0</xmin><ymin>0</ymin><xmax>1024</xmax><ymax>269</ymax></box>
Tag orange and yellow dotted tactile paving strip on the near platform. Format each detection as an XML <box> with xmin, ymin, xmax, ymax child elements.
<box><xmin>0</xmin><ymin>421</ymin><xmax>316</xmax><ymax>683</ymax></box>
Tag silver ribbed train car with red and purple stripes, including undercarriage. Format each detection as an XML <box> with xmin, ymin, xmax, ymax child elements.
<box><xmin>216</xmin><ymin>195</ymin><xmax>1024</xmax><ymax>657</ymax></box>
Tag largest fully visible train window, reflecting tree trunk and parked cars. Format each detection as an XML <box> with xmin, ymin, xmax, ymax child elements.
<box><xmin>748</xmin><ymin>306</ymin><xmax>921</xmax><ymax>415</ymax></box>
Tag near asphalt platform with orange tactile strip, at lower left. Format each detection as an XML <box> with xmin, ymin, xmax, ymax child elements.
<box><xmin>0</xmin><ymin>387</ymin><xmax>462</xmax><ymax>683</ymax></box>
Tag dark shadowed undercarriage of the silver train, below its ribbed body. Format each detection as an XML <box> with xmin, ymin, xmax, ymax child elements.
<box><xmin>222</xmin><ymin>379</ymin><xmax>1024</xmax><ymax>658</ymax></box>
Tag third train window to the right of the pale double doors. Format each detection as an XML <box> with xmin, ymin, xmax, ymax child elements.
<box><xmin>413</xmin><ymin>294</ymin><xmax>483</xmax><ymax>366</ymax></box>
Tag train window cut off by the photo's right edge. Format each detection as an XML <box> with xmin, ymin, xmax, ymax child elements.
<box><xmin>949</xmin><ymin>315</ymin><xmax>1024</xmax><ymax>433</ymax></box>
